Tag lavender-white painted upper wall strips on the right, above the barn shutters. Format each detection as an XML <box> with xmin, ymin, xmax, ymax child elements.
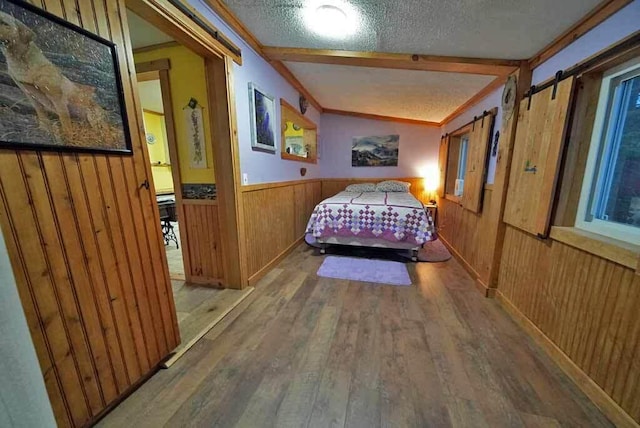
<box><xmin>442</xmin><ymin>0</ymin><xmax>640</xmax><ymax>184</ymax></box>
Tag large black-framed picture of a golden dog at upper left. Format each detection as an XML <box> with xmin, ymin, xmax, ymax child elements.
<box><xmin>0</xmin><ymin>0</ymin><xmax>132</xmax><ymax>154</ymax></box>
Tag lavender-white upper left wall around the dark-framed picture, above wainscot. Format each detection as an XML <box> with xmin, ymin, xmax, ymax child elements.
<box><xmin>188</xmin><ymin>0</ymin><xmax>322</xmax><ymax>184</ymax></box>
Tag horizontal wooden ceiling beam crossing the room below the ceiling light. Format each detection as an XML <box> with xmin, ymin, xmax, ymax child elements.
<box><xmin>263</xmin><ymin>46</ymin><xmax>520</xmax><ymax>76</ymax></box>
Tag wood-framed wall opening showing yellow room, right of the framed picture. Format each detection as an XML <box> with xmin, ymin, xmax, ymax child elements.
<box><xmin>280</xmin><ymin>99</ymin><xmax>318</xmax><ymax>163</ymax></box>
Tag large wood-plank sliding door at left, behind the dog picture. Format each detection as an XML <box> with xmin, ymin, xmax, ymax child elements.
<box><xmin>0</xmin><ymin>0</ymin><xmax>179</xmax><ymax>427</ymax></box>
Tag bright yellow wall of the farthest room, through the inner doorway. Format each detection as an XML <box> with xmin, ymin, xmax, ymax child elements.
<box><xmin>143</xmin><ymin>111</ymin><xmax>174</xmax><ymax>193</ymax></box>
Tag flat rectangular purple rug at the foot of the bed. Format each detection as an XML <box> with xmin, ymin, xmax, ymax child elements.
<box><xmin>318</xmin><ymin>256</ymin><xmax>411</xmax><ymax>286</ymax></box>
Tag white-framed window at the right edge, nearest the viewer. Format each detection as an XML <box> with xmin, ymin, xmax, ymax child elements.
<box><xmin>576</xmin><ymin>59</ymin><xmax>640</xmax><ymax>244</ymax></box>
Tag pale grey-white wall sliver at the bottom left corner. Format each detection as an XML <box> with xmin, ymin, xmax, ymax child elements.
<box><xmin>0</xmin><ymin>230</ymin><xmax>56</xmax><ymax>428</ymax></box>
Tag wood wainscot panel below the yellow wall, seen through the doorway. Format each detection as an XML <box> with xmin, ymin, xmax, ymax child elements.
<box><xmin>180</xmin><ymin>200</ymin><xmax>225</xmax><ymax>285</ymax></box>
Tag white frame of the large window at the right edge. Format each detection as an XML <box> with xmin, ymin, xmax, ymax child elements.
<box><xmin>575</xmin><ymin>57</ymin><xmax>640</xmax><ymax>244</ymax></box>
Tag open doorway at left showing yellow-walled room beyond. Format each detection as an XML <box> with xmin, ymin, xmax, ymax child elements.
<box><xmin>127</xmin><ymin>10</ymin><xmax>253</xmax><ymax>366</ymax></box>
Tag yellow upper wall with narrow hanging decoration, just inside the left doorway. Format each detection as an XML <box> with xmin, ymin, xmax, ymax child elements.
<box><xmin>134</xmin><ymin>46</ymin><xmax>216</xmax><ymax>184</ymax></box>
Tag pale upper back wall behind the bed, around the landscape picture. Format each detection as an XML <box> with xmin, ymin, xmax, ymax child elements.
<box><xmin>320</xmin><ymin>114</ymin><xmax>441</xmax><ymax>178</ymax></box>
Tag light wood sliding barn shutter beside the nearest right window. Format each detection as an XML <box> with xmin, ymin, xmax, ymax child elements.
<box><xmin>504</xmin><ymin>77</ymin><xmax>575</xmax><ymax>236</ymax></box>
